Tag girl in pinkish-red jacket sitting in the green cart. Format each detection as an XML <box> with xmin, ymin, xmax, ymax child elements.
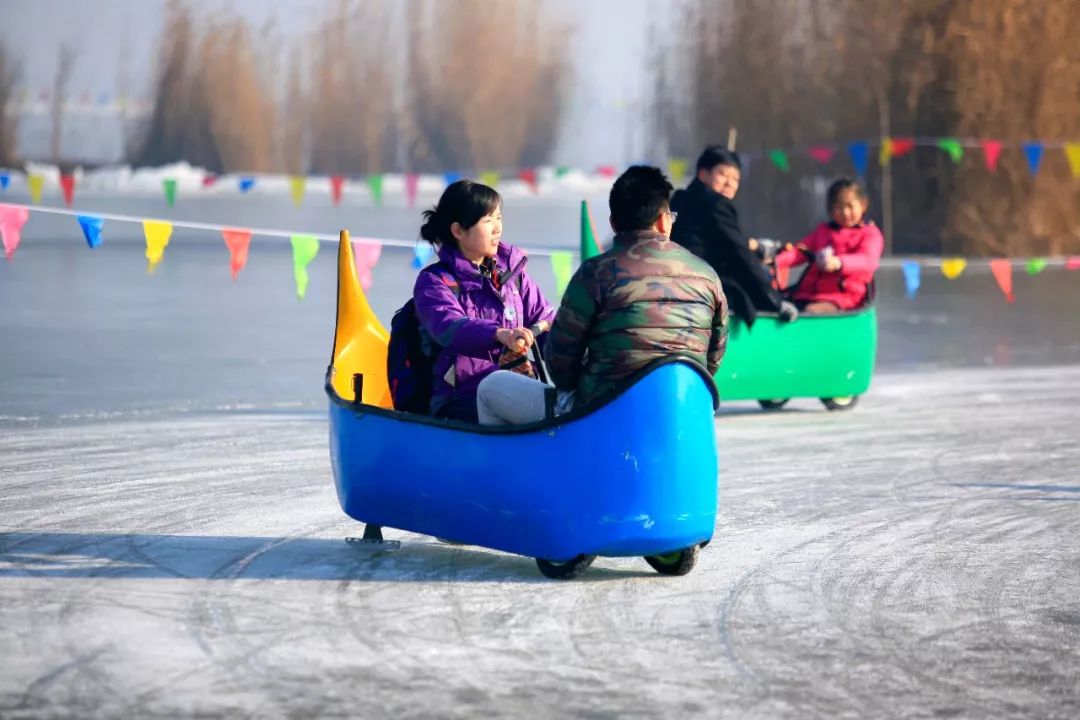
<box><xmin>777</xmin><ymin>178</ymin><xmax>885</xmax><ymax>314</ymax></box>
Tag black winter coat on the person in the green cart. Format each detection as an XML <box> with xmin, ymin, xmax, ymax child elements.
<box><xmin>671</xmin><ymin>179</ymin><xmax>783</xmax><ymax>326</ymax></box>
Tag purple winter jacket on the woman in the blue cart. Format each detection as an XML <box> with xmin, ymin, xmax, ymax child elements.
<box><xmin>413</xmin><ymin>243</ymin><xmax>555</xmax><ymax>421</ymax></box>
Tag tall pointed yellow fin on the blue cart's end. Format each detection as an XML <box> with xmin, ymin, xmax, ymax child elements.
<box><xmin>330</xmin><ymin>230</ymin><xmax>393</xmax><ymax>409</ymax></box>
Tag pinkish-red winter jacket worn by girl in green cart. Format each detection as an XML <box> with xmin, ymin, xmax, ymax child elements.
<box><xmin>777</xmin><ymin>222</ymin><xmax>885</xmax><ymax>310</ymax></box>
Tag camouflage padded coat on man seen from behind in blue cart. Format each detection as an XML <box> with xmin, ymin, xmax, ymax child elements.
<box><xmin>546</xmin><ymin>230</ymin><xmax>728</xmax><ymax>405</ymax></box>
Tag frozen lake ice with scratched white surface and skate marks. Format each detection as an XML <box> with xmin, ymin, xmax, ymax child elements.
<box><xmin>0</xmin><ymin>199</ymin><xmax>1080</xmax><ymax>719</ymax></box>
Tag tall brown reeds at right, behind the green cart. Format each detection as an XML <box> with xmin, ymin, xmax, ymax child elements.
<box><xmin>654</xmin><ymin>0</ymin><xmax>1080</xmax><ymax>256</ymax></box>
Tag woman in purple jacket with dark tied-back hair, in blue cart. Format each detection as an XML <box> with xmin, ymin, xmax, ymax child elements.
<box><xmin>413</xmin><ymin>180</ymin><xmax>555</xmax><ymax>422</ymax></box>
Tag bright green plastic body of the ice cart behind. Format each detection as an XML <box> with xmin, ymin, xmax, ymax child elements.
<box><xmin>715</xmin><ymin>305</ymin><xmax>877</xmax><ymax>400</ymax></box>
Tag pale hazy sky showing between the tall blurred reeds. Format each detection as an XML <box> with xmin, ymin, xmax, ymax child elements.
<box><xmin>0</xmin><ymin>0</ymin><xmax>656</xmax><ymax>166</ymax></box>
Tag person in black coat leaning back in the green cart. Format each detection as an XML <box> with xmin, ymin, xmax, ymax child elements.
<box><xmin>671</xmin><ymin>146</ymin><xmax>798</xmax><ymax>327</ymax></box>
